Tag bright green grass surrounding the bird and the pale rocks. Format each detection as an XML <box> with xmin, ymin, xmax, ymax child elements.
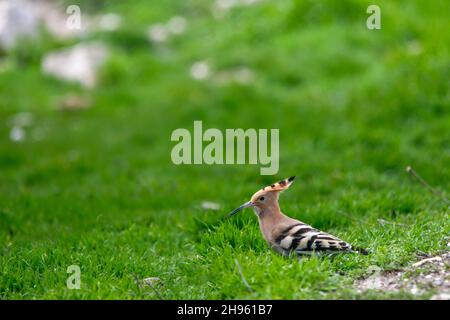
<box><xmin>0</xmin><ymin>0</ymin><xmax>450</xmax><ymax>299</ymax></box>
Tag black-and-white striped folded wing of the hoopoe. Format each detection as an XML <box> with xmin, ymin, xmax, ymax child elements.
<box><xmin>275</xmin><ymin>222</ymin><xmax>352</xmax><ymax>253</ymax></box>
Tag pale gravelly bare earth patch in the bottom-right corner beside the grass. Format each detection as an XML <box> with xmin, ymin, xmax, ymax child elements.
<box><xmin>355</xmin><ymin>252</ymin><xmax>450</xmax><ymax>300</ymax></box>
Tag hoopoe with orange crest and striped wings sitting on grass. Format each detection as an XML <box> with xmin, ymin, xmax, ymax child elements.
<box><xmin>228</xmin><ymin>176</ymin><xmax>367</xmax><ymax>258</ymax></box>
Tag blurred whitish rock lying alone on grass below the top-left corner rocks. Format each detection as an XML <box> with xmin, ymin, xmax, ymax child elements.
<box><xmin>42</xmin><ymin>42</ymin><xmax>108</xmax><ymax>88</ymax></box>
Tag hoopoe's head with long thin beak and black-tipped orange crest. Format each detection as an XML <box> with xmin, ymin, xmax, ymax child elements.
<box><xmin>228</xmin><ymin>176</ymin><xmax>295</xmax><ymax>217</ymax></box>
